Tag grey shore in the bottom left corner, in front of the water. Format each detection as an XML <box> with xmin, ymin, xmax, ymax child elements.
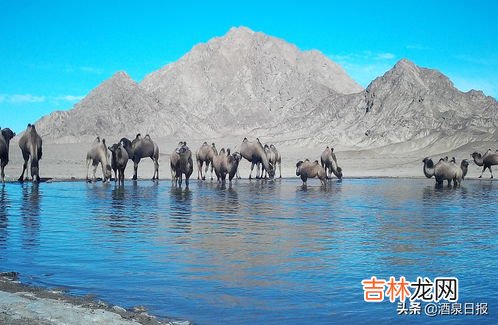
<box><xmin>0</xmin><ymin>272</ymin><xmax>191</xmax><ymax>325</ymax></box>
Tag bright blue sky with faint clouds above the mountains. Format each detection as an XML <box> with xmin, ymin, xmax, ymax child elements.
<box><xmin>0</xmin><ymin>0</ymin><xmax>498</xmax><ymax>131</ymax></box>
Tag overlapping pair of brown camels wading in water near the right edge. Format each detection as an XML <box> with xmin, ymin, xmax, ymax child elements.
<box><xmin>422</xmin><ymin>158</ymin><xmax>468</xmax><ymax>187</ymax></box>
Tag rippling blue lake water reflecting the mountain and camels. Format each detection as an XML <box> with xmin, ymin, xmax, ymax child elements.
<box><xmin>0</xmin><ymin>179</ymin><xmax>498</xmax><ymax>324</ymax></box>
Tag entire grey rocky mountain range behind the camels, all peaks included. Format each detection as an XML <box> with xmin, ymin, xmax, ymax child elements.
<box><xmin>33</xmin><ymin>27</ymin><xmax>498</xmax><ymax>150</ymax></box>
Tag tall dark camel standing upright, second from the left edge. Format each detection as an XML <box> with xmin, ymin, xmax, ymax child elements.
<box><xmin>18</xmin><ymin>124</ymin><xmax>43</xmax><ymax>183</ymax></box>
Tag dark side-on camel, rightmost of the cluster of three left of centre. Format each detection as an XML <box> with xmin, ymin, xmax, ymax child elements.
<box><xmin>119</xmin><ymin>133</ymin><xmax>159</xmax><ymax>180</ymax></box>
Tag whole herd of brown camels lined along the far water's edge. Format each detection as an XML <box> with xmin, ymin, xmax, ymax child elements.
<box><xmin>0</xmin><ymin>124</ymin><xmax>498</xmax><ymax>187</ymax></box>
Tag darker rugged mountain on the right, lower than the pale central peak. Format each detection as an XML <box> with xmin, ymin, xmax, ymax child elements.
<box><xmin>289</xmin><ymin>59</ymin><xmax>498</xmax><ymax>150</ymax></box>
